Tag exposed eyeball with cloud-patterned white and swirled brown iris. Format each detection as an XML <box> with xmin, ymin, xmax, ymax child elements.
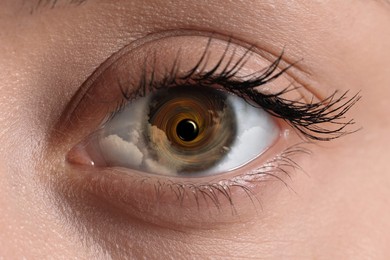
<box><xmin>74</xmin><ymin>86</ymin><xmax>280</xmax><ymax>176</ymax></box>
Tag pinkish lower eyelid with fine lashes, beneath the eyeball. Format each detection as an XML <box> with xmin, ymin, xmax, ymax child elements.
<box><xmin>62</xmin><ymin>128</ymin><xmax>306</xmax><ymax>229</ymax></box>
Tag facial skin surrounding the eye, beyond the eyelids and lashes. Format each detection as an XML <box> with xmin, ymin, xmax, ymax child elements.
<box><xmin>0</xmin><ymin>0</ymin><xmax>390</xmax><ymax>259</ymax></box>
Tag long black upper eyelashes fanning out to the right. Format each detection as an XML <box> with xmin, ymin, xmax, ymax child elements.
<box><xmin>117</xmin><ymin>37</ymin><xmax>361</xmax><ymax>141</ymax></box>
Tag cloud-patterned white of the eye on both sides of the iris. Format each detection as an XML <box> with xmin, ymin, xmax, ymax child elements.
<box><xmin>98</xmin><ymin>90</ymin><xmax>280</xmax><ymax>176</ymax></box>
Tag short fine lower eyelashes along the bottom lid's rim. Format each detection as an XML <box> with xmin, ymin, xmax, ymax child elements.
<box><xmin>136</xmin><ymin>143</ymin><xmax>311</xmax><ymax>215</ymax></box>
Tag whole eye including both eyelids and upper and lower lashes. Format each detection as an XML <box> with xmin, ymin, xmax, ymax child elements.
<box><xmin>60</xmin><ymin>35</ymin><xmax>359</xmax><ymax>229</ymax></box>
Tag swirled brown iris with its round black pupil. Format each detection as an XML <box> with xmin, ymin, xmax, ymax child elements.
<box><xmin>146</xmin><ymin>87</ymin><xmax>236</xmax><ymax>173</ymax></box>
